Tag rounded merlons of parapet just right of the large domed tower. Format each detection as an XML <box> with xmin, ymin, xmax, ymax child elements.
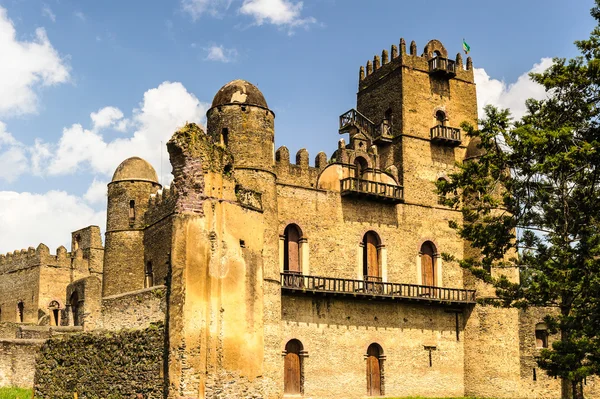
<box><xmin>275</xmin><ymin>146</ymin><xmax>328</xmax><ymax>187</ymax></box>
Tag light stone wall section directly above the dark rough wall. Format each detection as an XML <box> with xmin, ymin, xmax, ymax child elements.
<box><xmin>101</xmin><ymin>285</ymin><xmax>167</xmax><ymax>330</ymax></box>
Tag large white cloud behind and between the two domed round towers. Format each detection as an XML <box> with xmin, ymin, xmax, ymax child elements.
<box><xmin>43</xmin><ymin>82</ymin><xmax>208</xmax><ymax>183</ymax></box>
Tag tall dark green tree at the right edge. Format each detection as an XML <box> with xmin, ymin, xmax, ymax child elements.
<box><xmin>438</xmin><ymin>0</ymin><xmax>600</xmax><ymax>397</ymax></box>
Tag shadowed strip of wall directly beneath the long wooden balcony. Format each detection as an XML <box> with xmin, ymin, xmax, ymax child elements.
<box><xmin>281</xmin><ymin>296</ymin><xmax>470</xmax><ymax>334</ymax></box>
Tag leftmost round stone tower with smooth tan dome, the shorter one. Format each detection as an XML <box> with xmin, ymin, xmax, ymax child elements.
<box><xmin>102</xmin><ymin>157</ymin><xmax>161</xmax><ymax>296</ymax></box>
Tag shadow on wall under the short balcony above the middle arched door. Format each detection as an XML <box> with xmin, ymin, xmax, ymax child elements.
<box><xmin>342</xmin><ymin>198</ymin><xmax>398</xmax><ymax>227</ymax></box>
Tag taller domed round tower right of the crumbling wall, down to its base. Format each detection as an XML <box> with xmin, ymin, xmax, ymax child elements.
<box><xmin>207</xmin><ymin>80</ymin><xmax>281</xmax><ymax>390</ymax></box>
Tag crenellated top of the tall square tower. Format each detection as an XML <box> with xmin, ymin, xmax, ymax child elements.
<box><xmin>359</xmin><ymin>38</ymin><xmax>473</xmax><ymax>90</ymax></box>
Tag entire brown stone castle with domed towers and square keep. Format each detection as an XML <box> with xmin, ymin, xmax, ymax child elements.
<box><xmin>0</xmin><ymin>39</ymin><xmax>595</xmax><ymax>398</ymax></box>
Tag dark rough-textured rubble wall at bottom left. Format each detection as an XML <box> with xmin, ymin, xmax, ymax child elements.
<box><xmin>35</xmin><ymin>323</ymin><xmax>165</xmax><ymax>399</ymax></box>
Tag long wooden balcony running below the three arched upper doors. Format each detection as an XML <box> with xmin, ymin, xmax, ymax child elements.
<box><xmin>281</xmin><ymin>273</ymin><xmax>475</xmax><ymax>306</ymax></box>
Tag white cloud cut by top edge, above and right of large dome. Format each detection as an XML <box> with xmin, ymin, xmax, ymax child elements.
<box><xmin>240</xmin><ymin>0</ymin><xmax>317</xmax><ymax>28</ymax></box>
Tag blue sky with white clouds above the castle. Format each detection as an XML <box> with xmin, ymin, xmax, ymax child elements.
<box><xmin>0</xmin><ymin>0</ymin><xmax>595</xmax><ymax>253</ymax></box>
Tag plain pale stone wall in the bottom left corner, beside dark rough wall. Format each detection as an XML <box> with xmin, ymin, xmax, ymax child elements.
<box><xmin>0</xmin><ymin>339</ymin><xmax>44</xmax><ymax>388</ymax></box>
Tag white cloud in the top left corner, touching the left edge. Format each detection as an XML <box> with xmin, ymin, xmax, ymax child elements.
<box><xmin>0</xmin><ymin>7</ymin><xmax>70</xmax><ymax>115</ymax></box>
